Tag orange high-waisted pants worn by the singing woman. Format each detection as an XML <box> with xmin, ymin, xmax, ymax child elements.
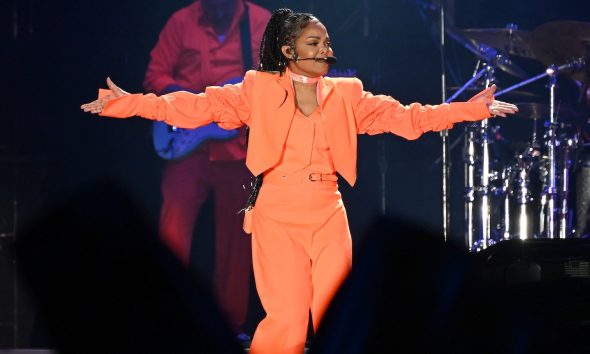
<box><xmin>250</xmin><ymin>174</ymin><xmax>352</xmax><ymax>354</ymax></box>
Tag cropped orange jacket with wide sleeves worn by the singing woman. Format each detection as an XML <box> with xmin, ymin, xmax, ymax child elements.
<box><xmin>101</xmin><ymin>70</ymin><xmax>490</xmax><ymax>185</ymax></box>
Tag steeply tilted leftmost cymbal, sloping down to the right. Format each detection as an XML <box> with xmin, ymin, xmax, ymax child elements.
<box><xmin>445</xmin><ymin>26</ymin><xmax>528</xmax><ymax>79</ymax></box>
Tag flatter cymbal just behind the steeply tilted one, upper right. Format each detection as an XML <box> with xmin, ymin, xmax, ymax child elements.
<box><xmin>461</xmin><ymin>28</ymin><xmax>535</xmax><ymax>58</ymax></box>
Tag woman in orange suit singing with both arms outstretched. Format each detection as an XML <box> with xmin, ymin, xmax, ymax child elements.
<box><xmin>82</xmin><ymin>9</ymin><xmax>517</xmax><ymax>354</ymax></box>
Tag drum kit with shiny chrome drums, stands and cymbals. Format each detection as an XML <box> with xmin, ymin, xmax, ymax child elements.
<box><xmin>446</xmin><ymin>20</ymin><xmax>590</xmax><ymax>251</ymax></box>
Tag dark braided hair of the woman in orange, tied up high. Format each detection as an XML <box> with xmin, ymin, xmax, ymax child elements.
<box><xmin>258</xmin><ymin>8</ymin><xmax>320</xmax><ymax>75</ymax></box>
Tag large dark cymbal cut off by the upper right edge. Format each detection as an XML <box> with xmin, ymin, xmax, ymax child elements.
<box><xmin>531</xmin><ymin>21</ymin><xmax>590</xmax><ymax>79</ymax></box>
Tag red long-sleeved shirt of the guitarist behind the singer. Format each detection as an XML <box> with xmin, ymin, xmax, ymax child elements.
<box><xmin>144</xmin><ymin>1</ymin><xmax>270</xmax><ymax>161</ymax></box>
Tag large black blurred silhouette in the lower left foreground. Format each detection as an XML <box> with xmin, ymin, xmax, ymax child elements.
<box><xmin>16</xmin><ymin>182</ymin><xmax>242</xmax><ymax>353</ymax></box>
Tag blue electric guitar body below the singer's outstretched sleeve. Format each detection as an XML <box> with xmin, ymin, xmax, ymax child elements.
<box><xmin>152</xmin><ymin>77</ymin><xmax>242</xmax><ymax>160</ymax></box>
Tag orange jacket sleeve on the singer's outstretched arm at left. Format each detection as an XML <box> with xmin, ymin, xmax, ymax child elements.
<box><xmin>99</xmin><ymin>71</ymin><xmax>254</xmax><ymax>129</ymax></box>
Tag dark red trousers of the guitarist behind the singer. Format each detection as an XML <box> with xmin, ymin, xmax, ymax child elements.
<box><xmin>160</xmin><ymin>151</ymin><xmax>252</xmax><ymax>331</ymax></box>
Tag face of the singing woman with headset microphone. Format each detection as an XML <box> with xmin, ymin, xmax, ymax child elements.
<box><xmin>281</xmin><ymin>22</ymin><xmax>334</xmax><ymax>77</ymax></box>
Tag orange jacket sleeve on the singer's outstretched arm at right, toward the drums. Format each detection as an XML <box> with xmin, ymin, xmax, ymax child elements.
<box><xmin>351</xmin><ymin>79</ymin><xmax>491</xmax><ymax>140</ymax></box>
